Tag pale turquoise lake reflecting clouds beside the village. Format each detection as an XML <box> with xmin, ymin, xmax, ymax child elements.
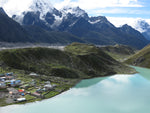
<box><xmin>0</xmin><ymin>67</ymin><xmax>150</xmax><ymax>113</ymax></box>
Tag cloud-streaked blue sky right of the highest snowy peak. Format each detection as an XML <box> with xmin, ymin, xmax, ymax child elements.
<box><xmin>50</xmin><ymin>0</ymin><xmax>150</xmax><ymax>19</ymax></box>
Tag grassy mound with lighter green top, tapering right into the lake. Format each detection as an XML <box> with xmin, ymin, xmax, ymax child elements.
<box><xmin>65</xmin><ymin>43</ymin><xmax>133</xmax><ymax>76</ymax></box>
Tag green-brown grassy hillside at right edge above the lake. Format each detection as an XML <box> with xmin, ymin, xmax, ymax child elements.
<box><xmin>125</xmin><ymin>45</ymin><xmax>150</xmax><ymax>68</ymax></box>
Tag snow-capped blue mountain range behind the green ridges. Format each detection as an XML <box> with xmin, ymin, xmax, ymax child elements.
<box><xmin>0</xmin><ymin>0</ymin><xmax>150</xmax><ymax>49</ymax></box>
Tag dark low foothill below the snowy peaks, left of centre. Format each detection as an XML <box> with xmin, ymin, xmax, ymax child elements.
<box><xmin>23</xmin><ymin>26</ymin><xmax>84</xmax><ymax>45</ymax></box>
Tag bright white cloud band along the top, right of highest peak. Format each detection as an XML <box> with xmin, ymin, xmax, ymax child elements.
<box><xmin>52</xmin><ymin>0</ymin><xmax>143</xmax><ymax>10</ymax></box>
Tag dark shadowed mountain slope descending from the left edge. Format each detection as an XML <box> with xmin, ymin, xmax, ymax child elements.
<box><xmin>0</xmin><ymin>9</ymin><xmax>33</xmax><ymax>42</ymax></box>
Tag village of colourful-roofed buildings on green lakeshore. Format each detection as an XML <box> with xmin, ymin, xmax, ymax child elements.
<box><xmin>0</xmin><ymin>72</ymin><xmax>67</xmax><ymax>104</ymax></box>
